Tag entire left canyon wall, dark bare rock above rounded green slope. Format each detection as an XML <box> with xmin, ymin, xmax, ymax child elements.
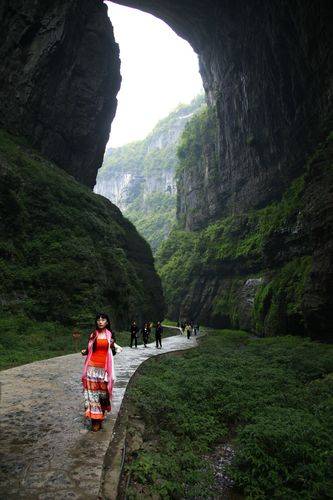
<box><xmin>0</xmin><ymin>0</ymin><xmax>164</xmax><ymax>328</ymax></box>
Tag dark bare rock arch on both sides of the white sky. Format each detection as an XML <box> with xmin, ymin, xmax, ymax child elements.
<box><xmin>0</xmin><ymin>0</ymin><xmax>332</xmax><ymax>199</ymax></box>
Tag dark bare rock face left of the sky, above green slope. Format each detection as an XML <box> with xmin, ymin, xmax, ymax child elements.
<box><xmin>0</xmin><ymin>0</ymin><xmax>120</xmax><ymax>187</ymax></box>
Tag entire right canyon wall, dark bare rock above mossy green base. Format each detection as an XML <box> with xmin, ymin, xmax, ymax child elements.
<box><xmin>113</xmin><ymin>0</ymin><xmax>333</xmax><ymax>339</ymax></box>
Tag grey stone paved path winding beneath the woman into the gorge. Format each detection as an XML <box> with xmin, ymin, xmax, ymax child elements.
<box><xmin>0</xmin><ymin>328</ymin><xmax>196</xmax><ymax>500</ymax></box>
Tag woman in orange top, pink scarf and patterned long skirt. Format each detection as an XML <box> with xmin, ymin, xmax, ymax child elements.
<box><xmin>81</xmin><ymin>313</ymin><xmax>115</xmax><ymax>432</ymax></box>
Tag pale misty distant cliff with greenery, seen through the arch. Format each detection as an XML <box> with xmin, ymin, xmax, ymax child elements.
<box><xmin>95</xmin><ymin>95</ymin><xmax>204</xmax><ymax>252</ymax></box>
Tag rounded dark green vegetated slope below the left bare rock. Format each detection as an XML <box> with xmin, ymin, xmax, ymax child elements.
<box><xmin>0</xmin><ymin>132</ymin><xmax>163</xmax><ymax>327</ymax></box>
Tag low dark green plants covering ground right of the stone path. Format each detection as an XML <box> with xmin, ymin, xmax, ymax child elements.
<box><xmin>126</xmin><ymin>330</ymin><xmax>333</xmax><ymax>499</ymax></box>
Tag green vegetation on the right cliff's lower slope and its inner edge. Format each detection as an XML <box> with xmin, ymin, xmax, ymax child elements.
<box><xmin>156</xmin><ymin>95</ymin><xmax>333</xmax><ymax>338</ymax></box>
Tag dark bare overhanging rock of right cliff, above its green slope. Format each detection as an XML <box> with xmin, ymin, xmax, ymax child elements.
<box><xmin>113</xmin><ymin>0</ymin><xmax>333</xmax><ymax>223</ymax></box>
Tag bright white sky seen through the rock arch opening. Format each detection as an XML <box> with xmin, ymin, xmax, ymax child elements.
<box><xmin>107</xmin><ymin>2</ymin><xmax>203</xmax><ymax>147</ymax></box>
